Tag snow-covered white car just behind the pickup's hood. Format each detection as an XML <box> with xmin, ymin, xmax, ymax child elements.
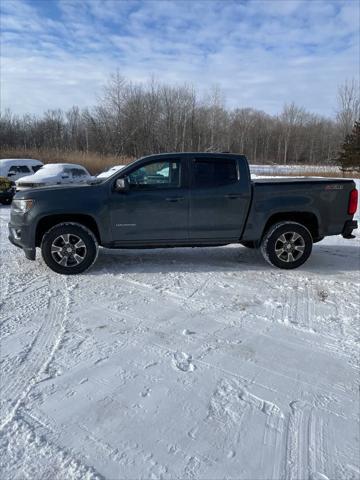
<box><xmin>15</xmin><ymin>163</ymin><xmax>92</xmax><ymax>191</ymax></box>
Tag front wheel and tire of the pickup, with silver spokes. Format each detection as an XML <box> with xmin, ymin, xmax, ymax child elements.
<box><xmin>41</xmin><ymin>222</ymin><xmax>99</xmax><ymax>275</ymax></box>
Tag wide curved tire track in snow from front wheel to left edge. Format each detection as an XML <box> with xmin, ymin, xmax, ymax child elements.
<box><xmin>0</xmin><ymin>279</ymin><xmax>70</xmax><ymax>431</ymax></box>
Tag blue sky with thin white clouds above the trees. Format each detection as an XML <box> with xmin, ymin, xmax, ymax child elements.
<box><xmin>1</xmin><ymin>0</ymin><xmax>360</xmax><ymax>116</ymax></box>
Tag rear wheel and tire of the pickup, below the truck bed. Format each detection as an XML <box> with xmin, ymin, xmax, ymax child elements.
<box><xmin>261</xmin><ymin>221</ymin><xmax>313</xmax><ymax>270</ymax></box>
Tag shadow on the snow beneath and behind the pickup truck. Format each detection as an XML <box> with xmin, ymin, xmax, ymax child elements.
<box><xmin>89</xmin><ymin>245</ymin><xmax>360</xmax><ymax>275</ymax></box>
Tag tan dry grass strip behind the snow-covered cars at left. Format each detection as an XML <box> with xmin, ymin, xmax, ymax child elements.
<box><xmin>0</xmin><ymin>149</ymin><xmax>133</xmax><ymax>175</ymax></box>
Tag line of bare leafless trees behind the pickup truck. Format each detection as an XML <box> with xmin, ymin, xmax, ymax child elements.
<box><xmin>0</xmin><ymin>73</ymin><xmax>360</xmax><ymax>165</ymax></box>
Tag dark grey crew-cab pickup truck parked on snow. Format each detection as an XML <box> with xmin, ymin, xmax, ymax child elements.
<box><xmin>9</xmin><ymin>153</ymin><xmax>358</xmax><ymax>274</ymax></box>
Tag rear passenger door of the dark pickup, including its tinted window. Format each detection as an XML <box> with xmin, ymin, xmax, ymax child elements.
<box><xmin>189</xmin><ymin>156</ymin><xmax>251</xmax><ymax>242</ymax></box>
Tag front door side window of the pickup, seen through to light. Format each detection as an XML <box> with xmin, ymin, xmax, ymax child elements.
<box><xmin>128</xmin><ymin>160</ymin><xmax>181</xmax><ymax>190</ymax></box>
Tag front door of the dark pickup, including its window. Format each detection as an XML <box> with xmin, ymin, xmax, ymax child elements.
<box><xmin>111</xmin><ymin>158</ymin><xmax>189</xmax><ymax>246</ymax></box>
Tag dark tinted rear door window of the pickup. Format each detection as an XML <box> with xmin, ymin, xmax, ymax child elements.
<box><xmin>193</xmin><ymin>158</ymin><xmax>238</xmax><ymax>188</ymax></box>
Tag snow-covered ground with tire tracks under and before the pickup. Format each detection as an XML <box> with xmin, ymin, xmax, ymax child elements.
<box><xmin>0</xmin><ymin>181</ymin><xmax>360</xmax><ymax>480</ymax></box>
